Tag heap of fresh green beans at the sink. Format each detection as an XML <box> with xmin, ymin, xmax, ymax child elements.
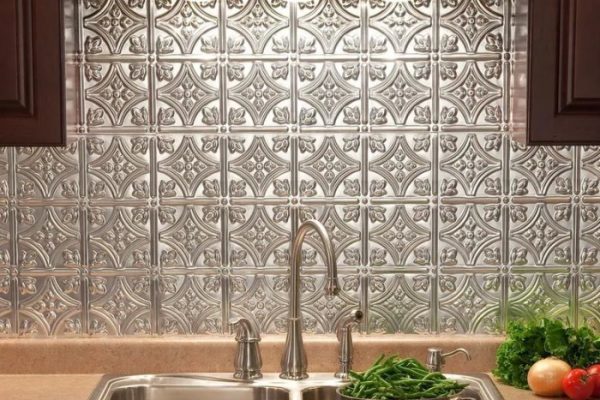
<box><xmin>341</xmin><ymin>355</ymin><xmax>468</xmax><ymax>400</ymax></box>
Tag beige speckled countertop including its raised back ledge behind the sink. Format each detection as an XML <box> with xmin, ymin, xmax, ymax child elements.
<box><xmin>0</xmin><ymin>335</ymin><xmax>564</xmax><ymax>400</ymax></box>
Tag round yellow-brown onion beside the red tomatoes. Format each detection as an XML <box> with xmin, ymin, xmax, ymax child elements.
<box><xmin>527</xmin><ymin>357</ymin><xmax>571</xmax><ymax>397</ymax></box>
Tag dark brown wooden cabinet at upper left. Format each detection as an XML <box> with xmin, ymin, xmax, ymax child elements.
<box><xmin>0</xmin><ymin>0</ymin><xmax>66</xmax><ymax>146</ymax></box>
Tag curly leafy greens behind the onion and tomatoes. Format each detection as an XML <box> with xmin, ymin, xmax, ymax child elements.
<box><xmin>493</xmin><ymin>319</ymin><xmax>600</xmax><ymax>389</ymax></box>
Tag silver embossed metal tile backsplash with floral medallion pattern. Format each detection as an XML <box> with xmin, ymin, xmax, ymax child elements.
<box><xmin>0</xmin><ymin>0</ymin><xmax>600</xmax><ymax>336</ymax></box>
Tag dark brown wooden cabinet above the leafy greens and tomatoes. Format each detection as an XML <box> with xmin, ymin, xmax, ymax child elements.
<box><xmin>514</xmin><ymin>0</ymin><xmax>600</xmax><ymax>145</ymax></box>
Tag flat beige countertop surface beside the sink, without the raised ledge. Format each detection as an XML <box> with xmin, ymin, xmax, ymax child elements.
<box><xmin>0</xmin><ymin>374</ymin><xmax>558</xmax><ymax>400</ymax></box>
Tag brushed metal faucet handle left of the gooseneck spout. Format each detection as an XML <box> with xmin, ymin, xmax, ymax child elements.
<box><xmin>229</xmin><ymin>318</ymin><xmax>262</xmax><ymax>380</ymax></box>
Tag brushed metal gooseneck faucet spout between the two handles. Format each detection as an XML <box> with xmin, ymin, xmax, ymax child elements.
<box><xmin>279</xmin><ymin>220</ymin><xmax>340</xmax><ymax>380</ymax></box>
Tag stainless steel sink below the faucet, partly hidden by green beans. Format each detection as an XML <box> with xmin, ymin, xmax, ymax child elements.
<box><xmin>90</xmin><ymin>374</ymin><xmax>503</xmax><ymax>400</ymax></box>
